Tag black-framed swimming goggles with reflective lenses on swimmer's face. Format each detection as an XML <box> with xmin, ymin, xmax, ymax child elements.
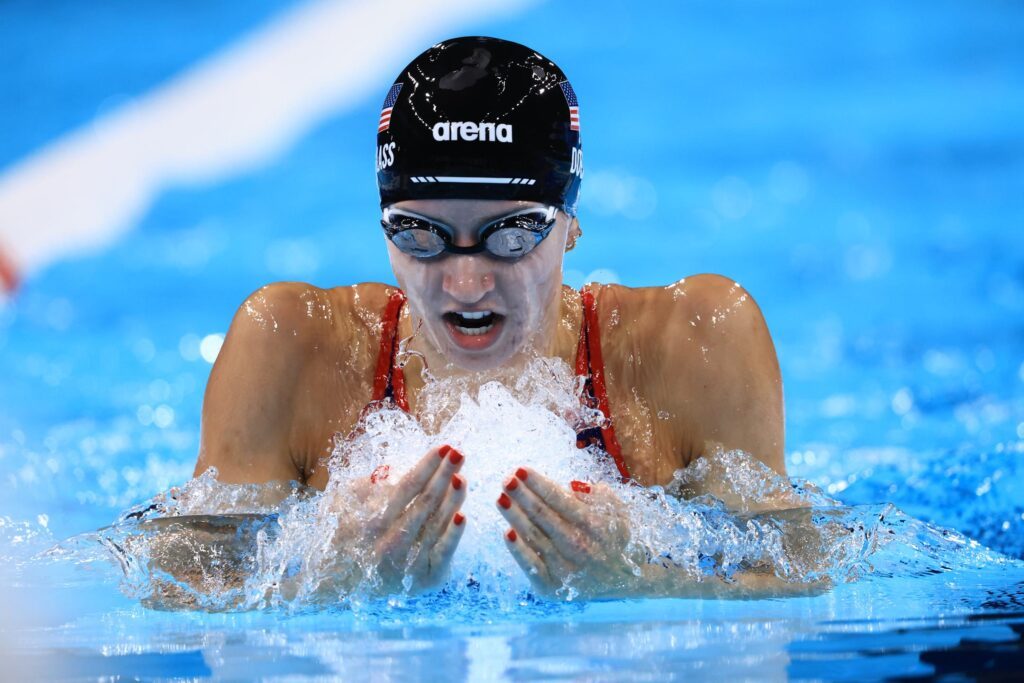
<box><xmin>381</xmin><ymin>206</ymin><xmax>558</xmax><ymax>261</ymax></box>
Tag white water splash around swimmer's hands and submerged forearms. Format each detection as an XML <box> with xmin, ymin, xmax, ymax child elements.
<box><xmin>51</xmin><ymin>359</ymin><xmax>1010</xmax><ymax>611</ymax></box>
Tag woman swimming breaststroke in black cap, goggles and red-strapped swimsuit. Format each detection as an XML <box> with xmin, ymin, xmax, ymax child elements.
<box><xmin>196</xmin><ymin>37</ymin><xmax>785</xmax><ymax>596</ymax></box>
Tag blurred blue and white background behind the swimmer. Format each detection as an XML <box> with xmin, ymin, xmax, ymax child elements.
<box><xmin>0</xmin><ymin>0</ymin><xmax>1024</xmax><ymax>556</ymax></box>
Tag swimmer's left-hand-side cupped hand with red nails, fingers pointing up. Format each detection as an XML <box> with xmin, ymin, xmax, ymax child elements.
<box><xmin>335</xmin><ymin>445</ymin><xmax>466</xmax><ymax>594</ymax></box>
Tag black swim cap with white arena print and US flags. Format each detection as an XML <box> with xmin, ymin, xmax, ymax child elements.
<box><xmin>377</xmin><ymin>36</ymin><xmax>583</xmax><ymax>215</ymax></box>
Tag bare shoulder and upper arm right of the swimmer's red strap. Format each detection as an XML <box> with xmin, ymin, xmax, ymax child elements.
<box><xmin>601</xmin><ymin>273</ymin><xmax>784</xmax><ymax>473</ymax></box>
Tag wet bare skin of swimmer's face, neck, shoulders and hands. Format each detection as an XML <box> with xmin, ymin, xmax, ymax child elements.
<box><xmin>196</xmin><ymin>200</ymin><xmax>785</xmax><ymax>595</ymax></box>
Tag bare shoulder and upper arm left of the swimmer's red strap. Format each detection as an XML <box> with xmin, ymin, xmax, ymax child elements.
<box><xmin>196</xmin><ymin>283</ymin><xmax>399</xmax><ymax>483</ymax></box>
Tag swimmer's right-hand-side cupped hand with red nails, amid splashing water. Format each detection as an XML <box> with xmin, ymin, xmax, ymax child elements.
<box><xmin>498</xmin><ymin>467</ymin><xmax>637</xmax><ymax>597</ymax></box>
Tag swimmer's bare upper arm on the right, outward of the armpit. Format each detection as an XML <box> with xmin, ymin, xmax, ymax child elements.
<box><xmin>665</xmin><ymin>274</ymin><xmax>785</xmax><ymax>474</ymax></box>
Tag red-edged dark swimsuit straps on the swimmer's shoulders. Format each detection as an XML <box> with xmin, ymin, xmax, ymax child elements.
<box><xmin>368</xmin><ymin>287</ymin><xmax>630</xmax><ymax>481</ymax></box>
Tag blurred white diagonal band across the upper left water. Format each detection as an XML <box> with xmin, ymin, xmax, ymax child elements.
<box><xmin>0</xmin><ymin>0</ymin><xmax>535</xmax><ymax>290</ymax></box>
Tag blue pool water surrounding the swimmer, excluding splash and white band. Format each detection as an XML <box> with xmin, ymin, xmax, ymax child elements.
<box><xmin>0</xmin><ymin>0</ymin><xmax>1024</xmax><ymax>680</ymax></box>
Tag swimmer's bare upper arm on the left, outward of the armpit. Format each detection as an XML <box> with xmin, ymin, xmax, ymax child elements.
<box><xmin>195</xmin><ymin>283</ymin><xmax>319</xmax><ymax>483</ymax></box>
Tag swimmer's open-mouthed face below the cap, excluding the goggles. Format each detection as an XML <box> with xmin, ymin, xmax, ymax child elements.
<box><xmin>387</xmin><ymin>200</ymin><xmax>571</xmax><ymax>371</ymax></box>
